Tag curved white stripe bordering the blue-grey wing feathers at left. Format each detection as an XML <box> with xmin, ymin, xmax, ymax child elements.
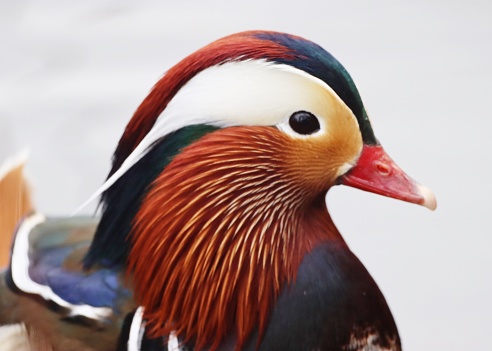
<box><xmin>11</xmin><ymin>213</ymin><xmax>112</xmax><ymax>320</ymax></box>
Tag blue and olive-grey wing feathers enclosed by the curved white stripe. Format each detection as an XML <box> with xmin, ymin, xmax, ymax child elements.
<box><xmin>13</xmin><ymin>217</ymin><xmax>132</xmax><ymax>313</ymax></box>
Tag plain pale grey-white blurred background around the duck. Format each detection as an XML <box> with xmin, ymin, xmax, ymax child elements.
<box><xmin>0</xmin><ymin>0</ymin><xmax>492</xmax><ymax>351</ymax></box>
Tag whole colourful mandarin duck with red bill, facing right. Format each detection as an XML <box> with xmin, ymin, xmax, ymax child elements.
<box><xmin>0</xmin><ymin>31</ymin><xmax>436</xmax><ymax>351</ymax></box>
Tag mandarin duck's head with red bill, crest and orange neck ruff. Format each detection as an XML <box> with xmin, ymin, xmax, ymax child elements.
<box><xmin>85</xmin><ymin>31</ymin><xmax>436</xmax><ymax>346</ymax></box>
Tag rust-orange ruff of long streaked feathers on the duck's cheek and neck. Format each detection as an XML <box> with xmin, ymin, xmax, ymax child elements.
<box><xmin>129</xmin><ymin>127</ymin><xmax>343</xmax><ymax>350</ymax></box>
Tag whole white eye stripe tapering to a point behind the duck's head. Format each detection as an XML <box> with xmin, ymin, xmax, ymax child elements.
<box><xmin>76</xmin><ymin>60</ymin><xmax>355</xmax><ymax>212</ymax></box>
